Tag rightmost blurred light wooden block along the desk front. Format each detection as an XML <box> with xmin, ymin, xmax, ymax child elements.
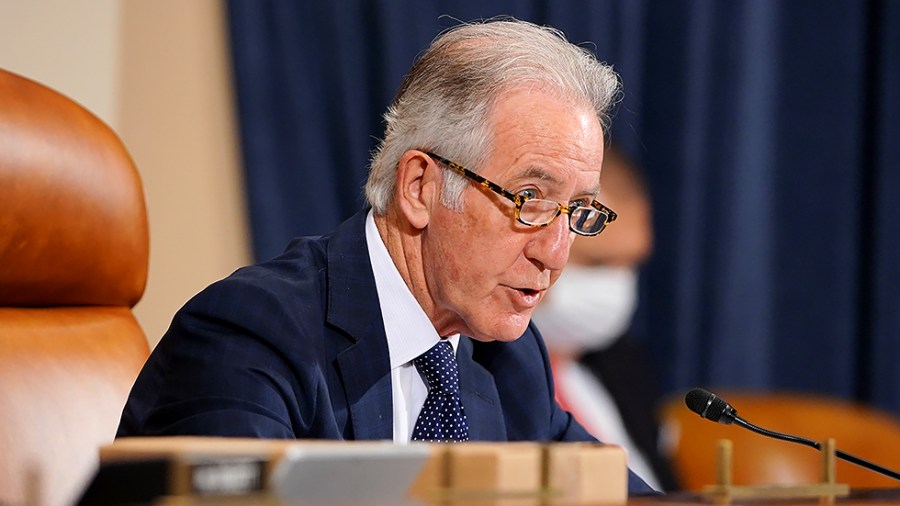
<box><xmin>545</xmin><ymin>443</ymin><xmax>628</xmax><ymax>504</ymax></box>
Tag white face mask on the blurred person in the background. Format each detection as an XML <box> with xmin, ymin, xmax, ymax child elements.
<box><xmin>533</xmin><ymin>265</ymin><xmax>637</xmax><ymax>354</ymax></box>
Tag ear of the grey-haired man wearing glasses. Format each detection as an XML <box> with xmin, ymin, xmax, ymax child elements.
<box><xmin>396</xmin><ymin>150</ymin><xmax>440</xmax><ymax>230</ymax></box>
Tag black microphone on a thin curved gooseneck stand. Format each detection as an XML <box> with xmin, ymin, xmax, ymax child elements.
<box><xmin>684</xmin><ymin>388</ymin><xmax>900</xmax><ymax>480</ymax></box>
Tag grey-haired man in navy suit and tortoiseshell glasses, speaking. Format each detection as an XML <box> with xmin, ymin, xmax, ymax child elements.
<box><xmin>117</xmin><ymin>21</ymin><xmax>652</xmax><ymax>493</ymax></box>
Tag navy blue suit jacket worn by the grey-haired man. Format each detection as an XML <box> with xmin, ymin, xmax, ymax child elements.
<box><xmin>117</xmin><ymin>212</ymin><xmax>652</xmax><ymax>493</ymax></box>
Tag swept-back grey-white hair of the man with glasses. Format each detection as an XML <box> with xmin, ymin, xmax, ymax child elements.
<box><xmin>365</xmin><ymin>18</ymin><xmax>620</xmax><ymax>214</ymax></box>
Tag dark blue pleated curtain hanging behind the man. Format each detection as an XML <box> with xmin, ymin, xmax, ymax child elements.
<box><xmin>229</xmin><ymin>0</ymin><xmax>900</xmax><ymax>414</ymax></box>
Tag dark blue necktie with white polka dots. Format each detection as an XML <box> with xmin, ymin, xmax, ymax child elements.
<box><xmin>412</xmin><ymin>341</ymin><xmax>469</xmax><ymax>442</ymax></box>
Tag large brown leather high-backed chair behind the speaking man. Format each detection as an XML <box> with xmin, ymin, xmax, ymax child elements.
<box><xmin>0</xmin><ymin>70</ymin><xmax>148</xmax><ymax>504</ymax></box>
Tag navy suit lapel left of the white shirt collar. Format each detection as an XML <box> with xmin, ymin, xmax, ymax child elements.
<box><xmin>326</xmin><ymin>211</ymin><xmax>394</xmax><ymax>439</ymax></box>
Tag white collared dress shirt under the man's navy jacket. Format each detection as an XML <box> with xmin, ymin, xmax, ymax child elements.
<box><xmin>366</xmin><ymin>210</ymin><xmax>459</xmax><ymax>443</ymax></box>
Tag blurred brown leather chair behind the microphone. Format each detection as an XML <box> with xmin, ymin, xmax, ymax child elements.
<box><xmin>662</xmin><ymin>392</ymin><xmax>900</xmax><ymax>491</ymax></box>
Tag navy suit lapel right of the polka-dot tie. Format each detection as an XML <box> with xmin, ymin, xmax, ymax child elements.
<box><xmin>456</xmin><ymin>336</ymin><xmax>507</xmax><ymax>441</ymax></box>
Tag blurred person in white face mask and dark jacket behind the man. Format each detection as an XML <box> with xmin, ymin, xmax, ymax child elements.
<box><xmin>534</xmin><ymin>145</ymin><xmax>678</xmax><ymax>490</ymax></box>
